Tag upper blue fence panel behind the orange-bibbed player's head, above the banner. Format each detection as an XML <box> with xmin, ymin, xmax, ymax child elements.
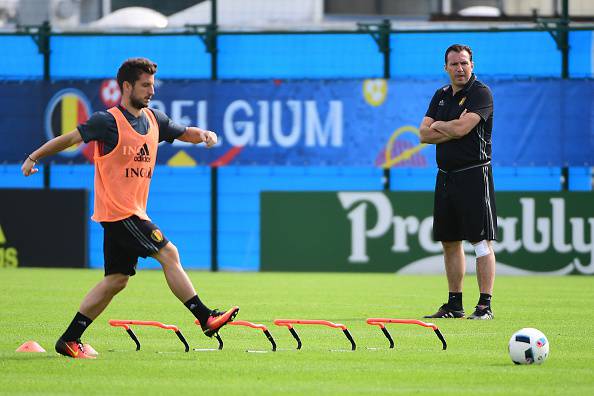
<box><xmin>51</xmin><ymin>36</ymin><xmax>210</xmax><ymax>79</ymax></box>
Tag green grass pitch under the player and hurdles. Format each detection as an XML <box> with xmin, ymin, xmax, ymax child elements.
<box><xmin>0</xmin><ymin>268</ymin><xmax>594</xmax><ymax>396</ymax></box>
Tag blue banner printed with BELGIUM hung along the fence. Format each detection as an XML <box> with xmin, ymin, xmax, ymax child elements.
<box><xmin>0</xmin><ymin>76</ymin><xmax>594</xmax><ymax>167</ymax></box>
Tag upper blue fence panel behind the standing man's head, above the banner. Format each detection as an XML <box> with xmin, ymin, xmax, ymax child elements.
<box><xmin>390</xmin><ymin>32</ymin><xmax>561</xmax><ymax>78</ymax></box>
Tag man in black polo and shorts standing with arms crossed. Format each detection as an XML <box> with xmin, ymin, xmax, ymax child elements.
<box><xmin>420</xmin><ymin>44</ymin><xmax>497</xmax><ymax>319</ymax></box>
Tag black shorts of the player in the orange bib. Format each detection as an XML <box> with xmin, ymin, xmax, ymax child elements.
<box><xmin>101</xmin><ymin>216</ymin><xmax>169</xmax><ymax>276</ymax></box>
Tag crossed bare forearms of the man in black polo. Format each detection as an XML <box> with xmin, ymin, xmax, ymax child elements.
<box><xmin>419</xmin><ymin>110</ymin><xmax>481</xmax><ymax>144</ymax></box>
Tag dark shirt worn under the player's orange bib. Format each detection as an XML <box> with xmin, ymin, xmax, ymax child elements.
<box><xmin>78</xmin><ymin>106</ymin><xmax>186</xmax><ymax>155</ymax></box>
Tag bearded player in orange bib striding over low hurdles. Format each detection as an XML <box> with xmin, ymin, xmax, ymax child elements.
<box><xmin>21</xmin><ymin>58</ymin><xmax>239</xmax><ymax>358</ymax></box>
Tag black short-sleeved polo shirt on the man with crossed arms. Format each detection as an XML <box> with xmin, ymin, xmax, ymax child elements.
<box><xmin>425</xmin><ymin>74</ymin><xmax>493</xmax><ymax>171</ymax></box>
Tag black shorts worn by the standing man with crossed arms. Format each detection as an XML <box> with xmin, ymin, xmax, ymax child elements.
<box><xmin>433</xmin><ymin>165</ymin><xmax>497</xmax><ymax>242</ymax></box>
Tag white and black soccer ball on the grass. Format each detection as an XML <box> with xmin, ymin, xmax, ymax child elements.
<box><xmin>509</xmin><ymin>327</ymin><xmax>549</xmax><ymax>364</ymax></box>
